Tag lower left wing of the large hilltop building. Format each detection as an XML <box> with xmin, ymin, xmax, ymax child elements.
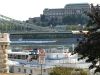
<box><xmin>43</xmin><ymin>8</ymin><xmax>65</xmax><ymax>23</ymax></box>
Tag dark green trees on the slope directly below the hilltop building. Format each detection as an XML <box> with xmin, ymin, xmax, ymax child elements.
<box><xmin>30</xmin><ymin>13</ymin><xmax>88</xmax><ymax>26</ymax></box>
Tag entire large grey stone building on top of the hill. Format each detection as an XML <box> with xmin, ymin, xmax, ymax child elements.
<box><xmin>43</xmin><ymin>3</ymin><xmax>90</xmax><ymax>24</ymax></box>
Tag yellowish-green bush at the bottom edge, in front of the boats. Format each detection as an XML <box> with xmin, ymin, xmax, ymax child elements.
<box><xmin>50</xmin><ymin>67</ymin><xmax>88</xmax><ymax>75</ymax></box>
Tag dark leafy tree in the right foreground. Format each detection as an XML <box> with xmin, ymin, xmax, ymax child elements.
<box><xmin>75</xmin><ymin>4</ymin><xmax>100</xmax><ymax>73</ymax></box>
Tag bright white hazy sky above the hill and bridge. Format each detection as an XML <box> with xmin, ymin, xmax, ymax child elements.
<box><xmin>0</xmin><ymin>0</ymin><xmax>100</xmax><ymax>20</ymax></box>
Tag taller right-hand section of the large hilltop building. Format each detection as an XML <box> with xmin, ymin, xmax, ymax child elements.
<box><xmin>64</xmin><ymin>3</ymin><xmax>90</xmax><ymax>15</ymax></box>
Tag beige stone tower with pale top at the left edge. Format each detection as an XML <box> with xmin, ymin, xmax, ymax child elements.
<box><xmin>0</xmin><ymin>33</ymin><xmax>10</xmax><ymax>73</ymax></box>
